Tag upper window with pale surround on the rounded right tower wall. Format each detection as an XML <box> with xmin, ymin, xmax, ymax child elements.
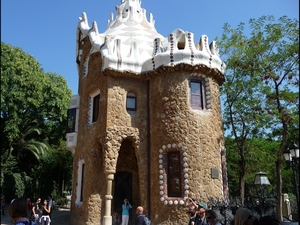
<box><xmin>190</xmin><ymin>80</ymin><xmax>206</xmax><ymax>110</ymax></box>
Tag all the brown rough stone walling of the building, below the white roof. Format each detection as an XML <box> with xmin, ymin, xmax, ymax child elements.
<box><xmin>71</xmin><ymin>36</ymin><xmax>224</xmax><ymax>225</ymax></box>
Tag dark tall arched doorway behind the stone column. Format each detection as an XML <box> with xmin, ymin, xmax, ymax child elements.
<box><xmin>113</xmin><ymin>139</ymin><xmax>140</xmax><ymax>225</ymax></box>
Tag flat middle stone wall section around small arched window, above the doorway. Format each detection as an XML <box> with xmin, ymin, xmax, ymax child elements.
<box><xmin>105</xmin><ymin>76</ymin><xmax>148</xmax><ymax>211</ymax></box>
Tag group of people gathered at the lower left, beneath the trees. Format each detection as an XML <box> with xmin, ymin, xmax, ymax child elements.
<box><xmin>1</xmin><ymin>195</ymin><xmax>54</xmax><ymax>225</ymax></box>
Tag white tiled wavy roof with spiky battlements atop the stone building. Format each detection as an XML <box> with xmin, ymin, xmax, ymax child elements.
<box><xmin>77</xmin><ymin>0</ymin><xmax>226</xmax><ymax>73</ymax></box>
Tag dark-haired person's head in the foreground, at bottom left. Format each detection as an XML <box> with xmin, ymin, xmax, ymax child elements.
<box><xmin>8</xmin><ymin>198</ymin><xmax>36</xmax><ymax>225</ymax></box>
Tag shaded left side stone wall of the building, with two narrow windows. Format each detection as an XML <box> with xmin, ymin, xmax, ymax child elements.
<box><xmin>71</xmin><ymin>39</ymin><xmax>107</xmax><ymax>225</ymax></box>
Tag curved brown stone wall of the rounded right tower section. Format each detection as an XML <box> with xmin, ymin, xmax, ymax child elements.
<box><xmin>150</xmin><ymin>71</ymin><xmax>223</xmax><ymax>224</ymax></box>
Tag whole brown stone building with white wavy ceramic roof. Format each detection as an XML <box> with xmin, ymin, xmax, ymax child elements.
<box><xmin>66</xmin><ymin>0</ymin><xmax>228</xmax><ymax>225</ymax></box>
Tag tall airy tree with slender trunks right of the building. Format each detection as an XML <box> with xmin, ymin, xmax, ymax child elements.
<box><xmin>219</xmin><ymin>16</ymin><xmax>299</xmax><ymax>220</ymax></box>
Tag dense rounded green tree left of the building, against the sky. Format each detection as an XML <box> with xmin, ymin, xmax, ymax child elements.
<box><xmin>1</xmin><ymin>42</ymin><xmax>72</xmax><ymax>199</ymax></box>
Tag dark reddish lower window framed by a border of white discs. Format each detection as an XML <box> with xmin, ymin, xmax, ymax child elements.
<box><xmin>167</xmin><ymin>152</ymin><xmax>181</xmax><ymax>197</ymax></box>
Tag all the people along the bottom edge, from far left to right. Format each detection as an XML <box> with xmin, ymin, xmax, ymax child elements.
<box><xmin>1</xmin><ymin>195</ymin><xmax>280</xmax><ymax>225</ymax></box>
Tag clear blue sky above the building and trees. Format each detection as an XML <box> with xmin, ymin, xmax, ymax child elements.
<box><xmin>1</xmin><ymin>0</ymin><xmax>299</xmax><ymax>94</ymax></box>
